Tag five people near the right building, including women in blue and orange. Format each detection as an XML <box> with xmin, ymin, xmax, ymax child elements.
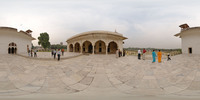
<box><xmin>138</xmin><ymin>49</ymin><xmax>171</xmax><ymax>63</ymax></box>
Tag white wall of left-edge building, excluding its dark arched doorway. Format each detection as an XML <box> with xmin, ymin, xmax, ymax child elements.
<box><xmin>0</xmin><ymin>29</ymin><xmax>32</xmax><ymax>54</ymax></box>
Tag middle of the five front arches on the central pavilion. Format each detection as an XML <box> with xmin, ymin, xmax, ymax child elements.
<box><xmin>82</xmin><ymin>41</ymin><xmax>93</xmax><ymax>53</ymax></box>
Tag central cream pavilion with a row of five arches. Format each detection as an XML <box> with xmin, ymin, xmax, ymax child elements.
<box><xmin>66</xmin><ymin>31</ymin><xmax>127</xmax><ymax>54</ymax></box>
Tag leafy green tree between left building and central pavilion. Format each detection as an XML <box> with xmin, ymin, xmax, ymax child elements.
<box><xmin>38</xmin><ymin>32</ymin><xmax>50</xmax><ymax>50</ymax></box>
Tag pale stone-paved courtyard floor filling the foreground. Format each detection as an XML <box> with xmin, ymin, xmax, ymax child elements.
<box><xmin>0</xmin><ymin>53</ymin><xmax>200</xmax><ymax>100</ymax></box>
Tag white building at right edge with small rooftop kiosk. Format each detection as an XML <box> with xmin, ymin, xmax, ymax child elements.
<box><xmin>175</xmin><ymin>24</ymin><xmax>200</xmax><ymax>54</ymax></box>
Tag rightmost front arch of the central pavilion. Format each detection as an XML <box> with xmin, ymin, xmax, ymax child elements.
<box><xmin>108</xmin><ymin>41</ymin><xmax>118</xmax><ymax>54</ymax></box>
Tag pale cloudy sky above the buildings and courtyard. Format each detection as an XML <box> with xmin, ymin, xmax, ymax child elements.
<box><xmin>0</xmin><ymin>0</ymin><xmax>200</xmax><ymax>49</ymax></box>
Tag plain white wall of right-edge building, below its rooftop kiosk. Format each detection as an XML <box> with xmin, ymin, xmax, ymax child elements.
<box><xmin>181</xmin><ymin>28</ymin><xmax>200</xmax><ymax>54</ymax></box>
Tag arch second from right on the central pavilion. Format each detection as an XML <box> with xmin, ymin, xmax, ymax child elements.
<box><xmin>94</xmin><ymin>40</ymin><xmax>106</xmax><ymax>54</ymax></box>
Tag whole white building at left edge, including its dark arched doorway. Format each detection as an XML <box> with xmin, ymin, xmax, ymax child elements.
<box><xmin>0</xmin><ymin>27</ymin><xmax>35</xmax><ymax>54</ymax></box>
